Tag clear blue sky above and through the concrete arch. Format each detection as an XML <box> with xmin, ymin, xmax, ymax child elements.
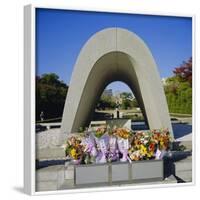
<box><xmin>36</xmin><ymin>9</ymin><xmax>192</xmax><ymax>91</ymax></box>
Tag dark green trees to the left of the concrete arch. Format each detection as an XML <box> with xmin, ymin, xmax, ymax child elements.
<box><xmin>36</xmin><ymin>73</ymin><xmax>68</xmax><ymax>121</ymax></box>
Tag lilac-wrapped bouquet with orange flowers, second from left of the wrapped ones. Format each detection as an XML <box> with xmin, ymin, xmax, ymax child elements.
<box><xmin>94</xmin><ymin>126</ymin><xmax>109</xmax><ymax>163</ymax></box>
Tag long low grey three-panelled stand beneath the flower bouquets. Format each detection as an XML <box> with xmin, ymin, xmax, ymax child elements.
<box><xmin>73</xmin><ymin>160</ymin><xmax>164</xmax><ymax>187</ymax></box>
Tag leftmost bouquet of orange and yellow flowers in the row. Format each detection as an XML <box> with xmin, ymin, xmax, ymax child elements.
<box><xmin>65</xmin><ymin>135</ymin><xmax>83</xmax><ymax>164</ymax></box>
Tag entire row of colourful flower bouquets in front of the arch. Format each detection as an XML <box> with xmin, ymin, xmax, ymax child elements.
<box><xmin>65</xmin><ymin>127</ymin><xmax>170</xmax><ymax>164</ymax></box>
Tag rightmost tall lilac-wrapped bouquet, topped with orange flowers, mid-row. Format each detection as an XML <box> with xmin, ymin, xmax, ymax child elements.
<box><xmin>114</xmin><ymin>128</ymin><xmax>131</xmax><ymax>162</ymax></box>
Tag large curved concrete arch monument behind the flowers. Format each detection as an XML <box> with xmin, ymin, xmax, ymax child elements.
<box><xmin>61</xmin><ymin>28</ymin><xmax>173</xmax><ymax>136</ymax></box>
